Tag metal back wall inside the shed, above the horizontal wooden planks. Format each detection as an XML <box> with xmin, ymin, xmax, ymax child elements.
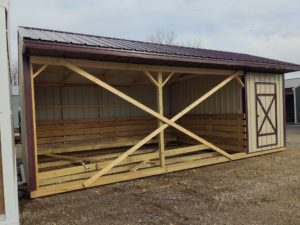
<box><xmin>36</xmin><ymin>86</ymin><xmax>169</xmax><ymax>120</ymax></box>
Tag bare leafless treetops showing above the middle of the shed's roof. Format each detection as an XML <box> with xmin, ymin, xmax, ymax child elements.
<box><xmin>147</xmin><ymin>30</ymin><xmax>201</xmax><ymax>48</ymax></box>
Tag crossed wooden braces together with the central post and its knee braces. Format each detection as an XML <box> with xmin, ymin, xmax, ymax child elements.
<box><xmin>30</xmin><ymin>59</ymin><xmax>241</xmax><ymax>190</ymax></box>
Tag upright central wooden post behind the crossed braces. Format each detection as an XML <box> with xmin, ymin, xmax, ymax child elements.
<box><xmin>157</xmin><ymin>72</ymin><xmax>166</xmax><ymax>167</ymax></box>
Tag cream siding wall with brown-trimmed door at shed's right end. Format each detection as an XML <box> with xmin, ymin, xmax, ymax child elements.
<box><xmin>246</xmin><ymin>73</ymin><xmax>285</xmax><ymax>152</ymax></box>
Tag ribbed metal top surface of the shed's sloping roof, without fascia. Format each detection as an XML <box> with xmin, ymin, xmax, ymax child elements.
<box><xmin>19</xmin><ymin>27</ymin><xmax>300</xmax><ymax>68</ymax></box>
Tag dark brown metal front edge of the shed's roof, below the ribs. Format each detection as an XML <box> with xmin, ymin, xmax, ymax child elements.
<box><xmin>22</xmin><ymin>37</ymin><xmax>300</xmax><ymax>73</ymax></box>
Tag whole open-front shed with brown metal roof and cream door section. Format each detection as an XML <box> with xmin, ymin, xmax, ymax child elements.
<box><xmin>19</xmin><ymin>27</ymin><xmax>300</xmax><ymax>198</ymax></box>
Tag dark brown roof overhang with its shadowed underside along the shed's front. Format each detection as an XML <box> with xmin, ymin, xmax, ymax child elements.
<box><xmin>23</xmin><ymin>38</ymin><xmax>300</xmax><ymax>73</ymax></box>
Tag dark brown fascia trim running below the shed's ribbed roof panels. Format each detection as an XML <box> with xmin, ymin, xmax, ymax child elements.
<box><xmin>23</xmin><ymin>39</ymin><xmax>300</xmax><ymax>73</ymax></box>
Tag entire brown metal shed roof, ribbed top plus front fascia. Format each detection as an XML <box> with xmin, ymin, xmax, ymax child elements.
<box><xmin>19</xmin><ymin>27</ymin><xmax>300</xmax><ymax>72</ymax></box>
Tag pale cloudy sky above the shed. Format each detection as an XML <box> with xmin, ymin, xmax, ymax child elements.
<box><xmin>10</xmin><ymin>0</ymin><xmax>300</xmax><ymax>78</ymax></box>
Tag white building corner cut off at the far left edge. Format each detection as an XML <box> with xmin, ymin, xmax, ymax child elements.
<box><xmin>0</xmin><ymin>0</ymin><xmax>19</xmax><ymax>225</ymax></box>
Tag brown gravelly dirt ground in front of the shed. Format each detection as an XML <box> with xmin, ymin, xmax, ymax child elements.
<box><xmin>20</xmin><ymin>126</ymin><xmax>300</xmax><ymax>225</ymax></box>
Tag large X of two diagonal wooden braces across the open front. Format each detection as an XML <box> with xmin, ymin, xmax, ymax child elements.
<box><xmin>59</xmin><ymin>59</ymin><xmax>241</xmax><ymax>187</ymax></box>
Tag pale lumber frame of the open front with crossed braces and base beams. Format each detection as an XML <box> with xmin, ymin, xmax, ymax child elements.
<box><xmin>25</xmin><ymin>56</ymin><xmax>284</xmax><ymax>197</ymax></box>
